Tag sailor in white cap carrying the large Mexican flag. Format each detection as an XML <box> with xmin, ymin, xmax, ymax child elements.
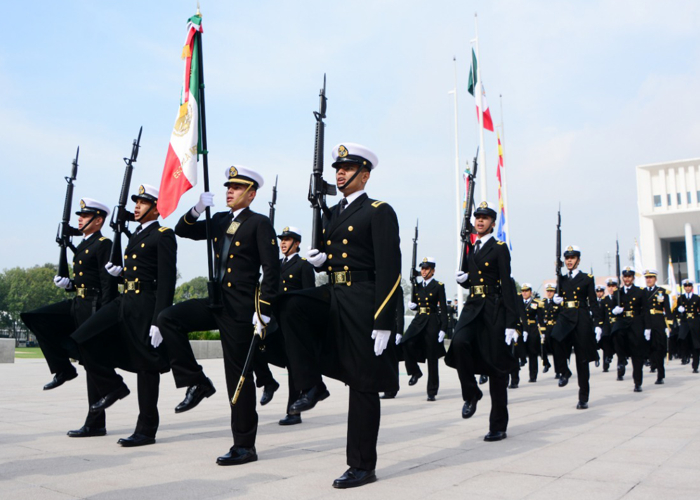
<box><xmin>158</xmin><ymin>165</ymin><xmax>280</xmax><ymax>465</ymax></box>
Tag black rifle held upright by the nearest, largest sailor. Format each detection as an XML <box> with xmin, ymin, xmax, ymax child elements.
<box><xmin>309</xmin><ymin>74</ymin><xmax>337</xmax><ymax>249</ymax></box>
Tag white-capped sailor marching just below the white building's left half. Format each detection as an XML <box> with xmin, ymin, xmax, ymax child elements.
<box><xmin>644</xmin><ymin>269</ymin><xmax>673</xmax><ymax>384</ymax></box>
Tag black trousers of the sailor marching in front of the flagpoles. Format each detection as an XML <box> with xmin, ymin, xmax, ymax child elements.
<box><xmin>450</xmin><ymin>315</ymin><xmax>508</xmax><ymax>432</ymax></box>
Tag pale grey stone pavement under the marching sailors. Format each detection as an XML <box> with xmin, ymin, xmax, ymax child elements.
<box><xmin>0</xmin><ymin>359</ymin><xmax>700</xmax><ymax>500</ymax></box>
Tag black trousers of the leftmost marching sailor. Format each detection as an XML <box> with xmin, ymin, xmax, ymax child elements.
<box><xmin>21</xmin><ymin>297</ymin><xmax>105</xmax><ymax>428</ymax></box>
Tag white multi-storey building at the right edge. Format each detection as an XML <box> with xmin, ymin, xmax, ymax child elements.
<box><xmin>637</xmin><ymin>158</ymin><xmax>700</xmax><ymax>284</ymax></box>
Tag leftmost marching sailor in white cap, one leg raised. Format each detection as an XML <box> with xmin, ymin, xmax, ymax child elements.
<box><xmin>20</xmin><ymin>198</ymin><xmax>118</xmax><ymax>437</ymax></box>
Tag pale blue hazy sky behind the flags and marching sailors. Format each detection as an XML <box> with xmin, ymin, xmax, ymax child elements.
<box><xmin>0</xmin><ymin>0</ymin><xmax>700</xmax><ymax>296</ymax></box>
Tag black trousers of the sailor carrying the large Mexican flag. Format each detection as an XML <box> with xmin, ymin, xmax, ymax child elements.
<box><xmin>158</xmin><ymin>299</ymin><xmax>258</xmax><ymax>448</ymax></box>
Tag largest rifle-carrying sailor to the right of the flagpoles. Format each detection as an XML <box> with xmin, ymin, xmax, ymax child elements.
<box><xmin>552</xmin><ymin>245</ymin><xmax>603</xmax><ymax>410</ymax></box>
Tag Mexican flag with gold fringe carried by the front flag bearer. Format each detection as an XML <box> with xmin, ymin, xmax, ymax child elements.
<box><xmin>158</xmin><ymin>13</ymin><xmax>202</xmax><ymax>218</ymax></box>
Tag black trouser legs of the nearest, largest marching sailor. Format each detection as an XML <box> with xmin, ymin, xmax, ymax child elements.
<box><xmin>282</xmin><ymin>295</ymin><xmax>381</xmax><ymax>470</ymax></box>
